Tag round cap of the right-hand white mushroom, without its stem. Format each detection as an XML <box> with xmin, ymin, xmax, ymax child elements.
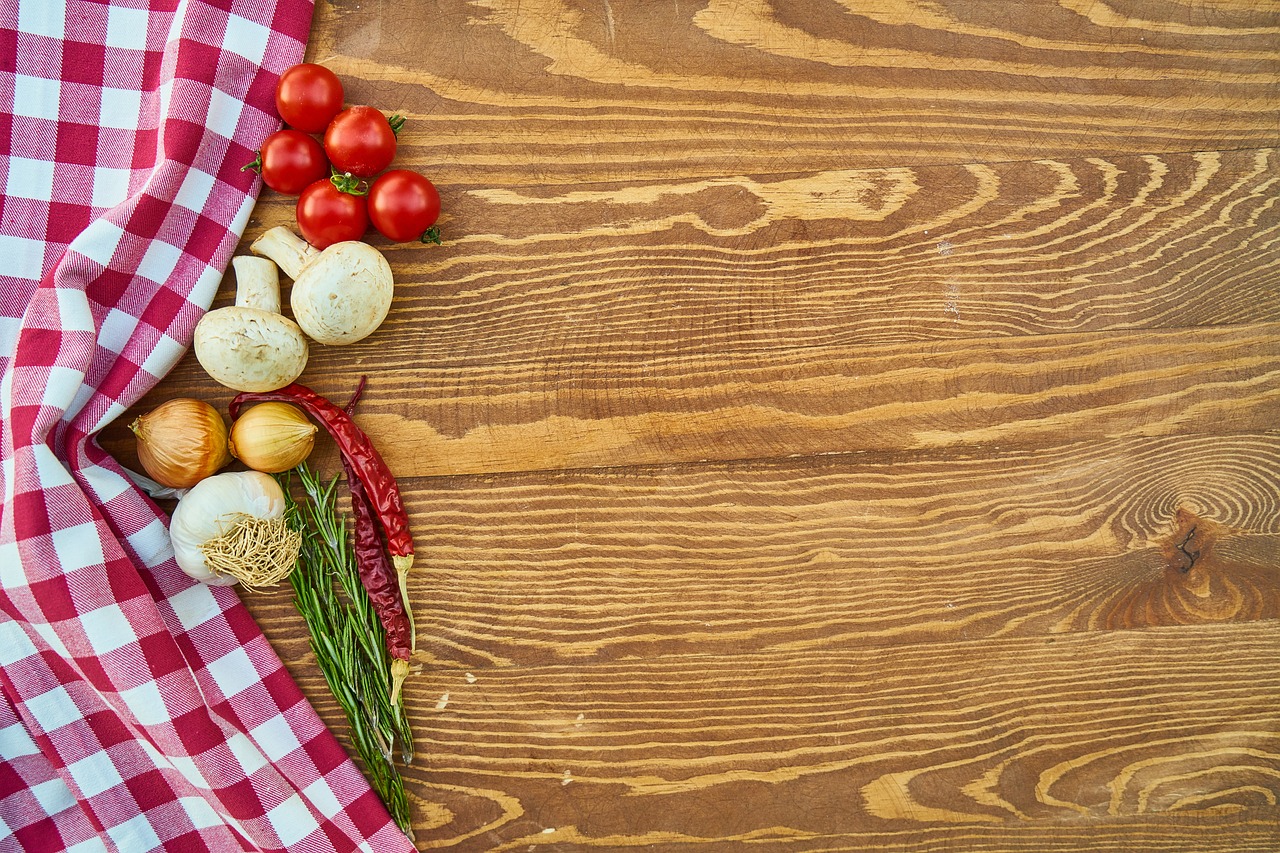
<box><xmin>289</xmin><ymin>241</ymin><xmax>394</xmax><ymax>346</ymax></box>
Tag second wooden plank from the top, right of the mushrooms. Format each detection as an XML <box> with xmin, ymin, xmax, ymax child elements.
<box><xmin>232</xmin><ymin>143</ymin><xmax>1280</xmax><ymax>368</ymax></box>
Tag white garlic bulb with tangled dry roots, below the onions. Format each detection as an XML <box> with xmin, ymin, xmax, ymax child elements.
<box><xmin>169</xmin><ymin>471</ymin><xmax>302</xmax><ymax>589</ymax></box>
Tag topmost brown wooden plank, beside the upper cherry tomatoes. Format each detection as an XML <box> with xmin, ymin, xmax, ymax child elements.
<box><xmin>308</xmin><ymin>0</ymin><xmax>1280</xmax><ymax>186</ymax></box>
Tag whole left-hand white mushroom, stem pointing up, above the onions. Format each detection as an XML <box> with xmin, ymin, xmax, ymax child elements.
<box><xmin>195</xmin><ymin>255</ymin><xmax>307</xmax><ymax>392</ymax></box>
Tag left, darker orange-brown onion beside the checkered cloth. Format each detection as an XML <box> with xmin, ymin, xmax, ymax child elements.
<box><xmin>129</xmin><ymin>397</ymin><xmax>232</xmax><ymax>489</ymax></box>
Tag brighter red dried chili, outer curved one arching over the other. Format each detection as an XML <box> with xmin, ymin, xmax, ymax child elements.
<box><xmin>229</xmin><ymin>383</ymin><xmax>416</xmax><ymax>666</ymax></box>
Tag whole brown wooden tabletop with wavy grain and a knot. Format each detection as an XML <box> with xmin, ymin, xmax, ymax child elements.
<box><xmin>106</xmin><ymin>0</ymin><xmax>1280</xmax><ymax>853</ymax></box>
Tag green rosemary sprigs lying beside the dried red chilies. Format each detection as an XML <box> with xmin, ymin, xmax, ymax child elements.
<box><xmin>282</xmin><ymin>465</ymin><xmax>413</xmax><ymax>838</ymax></box>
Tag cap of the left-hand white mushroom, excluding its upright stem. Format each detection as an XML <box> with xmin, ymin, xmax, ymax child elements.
<box><xmin>196</xmin><ymin>306</ymin><xmax>307</xmax><ymax>392</ymax></box>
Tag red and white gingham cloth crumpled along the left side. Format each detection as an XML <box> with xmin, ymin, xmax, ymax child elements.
<box><xmin>0</xmin><ymin>0</ymin><xmax>412</xmax><ymax>853</ymax></box>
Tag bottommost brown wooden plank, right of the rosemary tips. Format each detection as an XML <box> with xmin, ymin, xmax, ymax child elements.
<box><xmin>275</xmin><ymin>621</ymin><xmax>1280</xmax><ymax>853</ymax></box>
